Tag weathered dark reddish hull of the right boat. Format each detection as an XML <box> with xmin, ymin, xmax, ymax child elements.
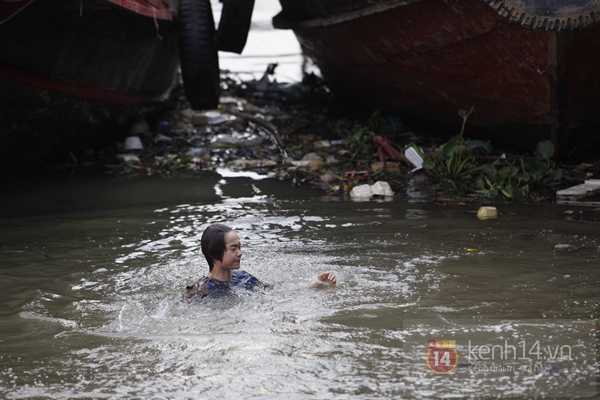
<box><xmin>274</xmin><ymin>0</ymin><xmax>600</xmax><ymax>151</ymax></box>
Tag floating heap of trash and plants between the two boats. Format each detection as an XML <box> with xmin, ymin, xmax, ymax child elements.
<box><xmin>74</xmin><ymin>65</ymin><xmax>600</xmax><ymax>202</ymax></box>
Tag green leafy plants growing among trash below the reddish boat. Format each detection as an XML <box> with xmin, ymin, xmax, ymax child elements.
<box><xmin>330</xmin><ymin>108</ymin><xmax>585</xmax><ymax>201</ymax></box>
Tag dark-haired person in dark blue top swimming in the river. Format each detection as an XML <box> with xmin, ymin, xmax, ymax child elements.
<box><xmin>184</xmin><ymin>224</ymin><xmax>336</xmax><ymax>300</ymax></box>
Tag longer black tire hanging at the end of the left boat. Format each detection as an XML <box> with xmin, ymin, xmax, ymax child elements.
<box><xmin>179</xmin><ymin>0</ymin><xmax>221</xmax><ymax>110</ymax></box>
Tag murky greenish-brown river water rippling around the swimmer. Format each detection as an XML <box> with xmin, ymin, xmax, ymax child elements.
<box><xmin>0</xmin><ymin>174</ymin><xmax>600</xmax><ymax>399</ymax></box>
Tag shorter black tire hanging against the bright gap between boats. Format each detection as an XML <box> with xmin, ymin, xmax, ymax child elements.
<box><xmin>217</xmin><ymin>0</ymin><xmax>254</xmax><ymax>54</ymax></box>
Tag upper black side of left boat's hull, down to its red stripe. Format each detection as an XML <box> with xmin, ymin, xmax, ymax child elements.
<box><xmin>0</xmin><ymin>0</ymin><xmax>179</xmax><ymax>105</ymax></box>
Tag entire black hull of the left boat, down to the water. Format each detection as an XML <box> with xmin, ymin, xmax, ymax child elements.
<box><xmin>0</xmin><ymin>0</ymin><xmax>179</xmax><ymax>174</ymax></box>
